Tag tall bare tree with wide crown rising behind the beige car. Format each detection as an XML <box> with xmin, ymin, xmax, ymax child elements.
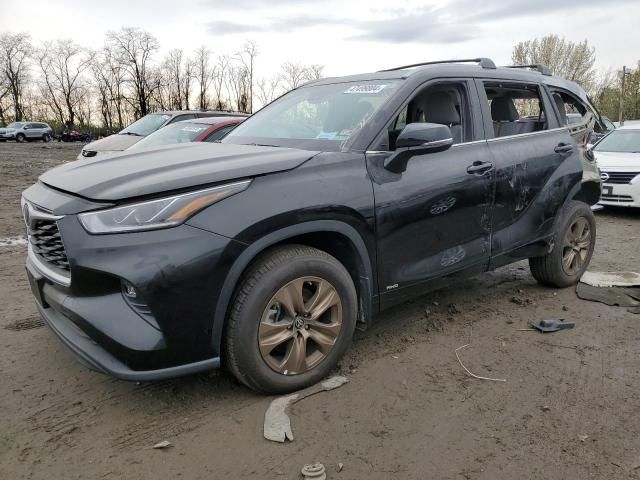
<box><xmin>107</xmin><ymin>27</ymin><xmax>160</xmax><ymax>116</ymax></box>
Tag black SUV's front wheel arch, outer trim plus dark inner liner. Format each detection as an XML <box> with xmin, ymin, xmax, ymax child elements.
<box><xmin>211</xmin><ymin>220</ymin><xmax>376</xmax><ymax>352</ymax></box>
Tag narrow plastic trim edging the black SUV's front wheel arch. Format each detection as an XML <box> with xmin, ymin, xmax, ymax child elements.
<box><xmin>211</xmin><ymin>220</ymin><xmax>374</xmax><ymax>353</ymax></box>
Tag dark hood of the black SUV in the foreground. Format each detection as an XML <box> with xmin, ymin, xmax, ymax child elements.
<box><xmin>40</xmin><ymin>142</ymin><xmax>318</xmax><ymax>201</ymax></box>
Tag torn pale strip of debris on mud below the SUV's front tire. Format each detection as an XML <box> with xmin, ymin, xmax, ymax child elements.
<box><xmin>262</xmin><ymin>375</ymin><xmax>349</xmax><ymax>442</ymax></box>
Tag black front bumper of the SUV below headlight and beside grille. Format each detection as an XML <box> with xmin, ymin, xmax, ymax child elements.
<box><xmin>26</xmin><ymin>202</ymin><xmax>243</xmax><ymax>381</ymax></box>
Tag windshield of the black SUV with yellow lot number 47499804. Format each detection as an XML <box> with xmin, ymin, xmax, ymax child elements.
<box><xmin>222</xmin><ymin>80</ymin><xmax>399</xmax><ymax>151</ymax></box>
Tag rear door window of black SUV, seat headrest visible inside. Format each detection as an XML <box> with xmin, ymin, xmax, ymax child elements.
<box><xmin>484</xmin><ymin>82</ymin><xmax>549</xmax><ymax>137</ymax></box>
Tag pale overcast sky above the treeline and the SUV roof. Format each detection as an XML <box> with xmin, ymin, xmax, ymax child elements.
<box><xmin>0</xmin><ymin>0</ymin><xmax>640</xmax><ymax>77</ymax></box>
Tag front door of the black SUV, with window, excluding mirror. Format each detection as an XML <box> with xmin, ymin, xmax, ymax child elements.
<box><xmin>367</xmin><ymin>81</ymin><xmax>494</xmax><ymax>308</ymax></box>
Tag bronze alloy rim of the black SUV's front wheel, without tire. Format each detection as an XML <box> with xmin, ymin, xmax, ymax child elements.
<box><xmin>258</xmin><ymin>277</ymin><xmax>342</xmax><ymax>375</ymax></box>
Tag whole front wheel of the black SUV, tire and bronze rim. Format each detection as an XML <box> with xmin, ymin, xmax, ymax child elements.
<box><xmin>223</xmin><ymin>245</ymin><xmax>357</xmax><ymax>394</ymax></box>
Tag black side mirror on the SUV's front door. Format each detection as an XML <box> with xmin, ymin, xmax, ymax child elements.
<box><xmin>384</xmin><ymin>123</ymin><xmax>453</xmax><ymax>173</ymax></box>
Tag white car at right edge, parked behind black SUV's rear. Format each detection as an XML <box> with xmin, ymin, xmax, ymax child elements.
<box><xmin>593</xmin><ymin>124</ymin><xmax>640</xmax><ymax>208</ymax></box>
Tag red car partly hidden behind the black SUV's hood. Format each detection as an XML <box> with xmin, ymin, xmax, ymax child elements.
<box><xmin>126</xmin><ymin>117</ymin><xmax>246</xmax><ymax>152</ymax></box>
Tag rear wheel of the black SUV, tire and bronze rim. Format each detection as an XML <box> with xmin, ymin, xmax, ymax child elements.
<box><xmin>529</xmin><ymin>200</ymin><xmax>596</xmax><ymax>288</ymax></box>
